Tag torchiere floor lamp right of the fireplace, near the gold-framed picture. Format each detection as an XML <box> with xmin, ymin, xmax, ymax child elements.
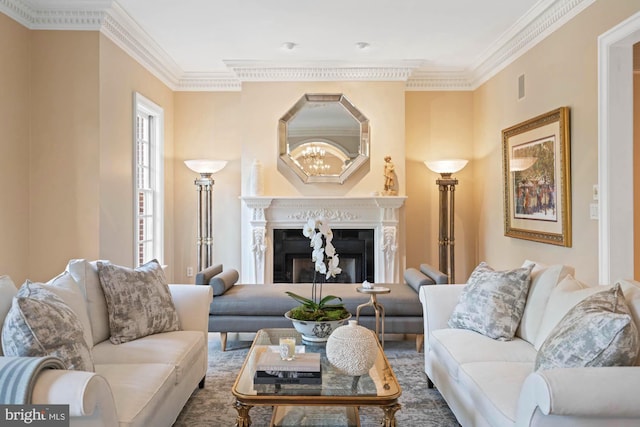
<box><xmin>424</xmin><ymin>159</ymin><xmax>468</xmax><ymax>283</ymax></box>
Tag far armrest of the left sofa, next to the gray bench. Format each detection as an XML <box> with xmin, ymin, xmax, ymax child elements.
<box><xmin>169</xmin><ymin>285</ymin><xmax>213</xmax><ymax>335</ymax></box>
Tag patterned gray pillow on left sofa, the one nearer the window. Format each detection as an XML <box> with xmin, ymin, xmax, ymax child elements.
<box><xmin>98</xmin><ymin>260</ymin><xmax>180</xmax><ymax>344</ymax></box>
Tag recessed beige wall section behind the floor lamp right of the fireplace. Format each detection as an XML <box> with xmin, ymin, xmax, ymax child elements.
<box><xmin>405</xmin><ymin>92</ymin><xmax>478</xmax><ymax>282</ymax></box>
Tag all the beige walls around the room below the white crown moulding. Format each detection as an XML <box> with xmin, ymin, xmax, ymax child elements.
<box><xmin>0</xmin><ymin>1</ymin><xmax>637</xmax><ymax>290</ymax></box>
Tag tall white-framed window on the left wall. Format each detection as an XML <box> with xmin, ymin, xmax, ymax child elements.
<box><xmin>133</xmin><ymin>93</ymin><xmax>164</xmax><ymax>266</ymax></box>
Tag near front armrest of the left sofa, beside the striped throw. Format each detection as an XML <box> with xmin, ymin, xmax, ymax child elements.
<box><xmin>31</xmin><ymin>369</ymin><xmax>118</xmax><ymax>426</ymax></box>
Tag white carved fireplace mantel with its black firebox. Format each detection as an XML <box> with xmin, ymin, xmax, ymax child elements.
<box><xmin>241</xmin><ymin>196</ymin><xmax>406</xmax><ymax>284</ymax></box>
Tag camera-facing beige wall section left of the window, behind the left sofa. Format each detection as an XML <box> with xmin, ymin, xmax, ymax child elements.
<box><xmin>29</xmin><ymin>31</ymin><xmax>100</xmax><ymax>280</ymax></box>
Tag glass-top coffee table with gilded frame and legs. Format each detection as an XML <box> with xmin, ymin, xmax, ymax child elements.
<box><xmin>231</xmin><ymin>329</ymin><xmax>402</xmax><ymax>427</ymax></box>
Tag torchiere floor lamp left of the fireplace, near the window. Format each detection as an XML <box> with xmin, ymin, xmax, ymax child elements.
<box><xmin>184</xmin><ymin>159</ymin><xmax>227</xmax><ymax>272</ymax></box>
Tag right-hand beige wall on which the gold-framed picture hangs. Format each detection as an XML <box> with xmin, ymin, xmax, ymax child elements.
<box><xmin>473</xmin><ymin>0</ymin><xmax>640</xmax><ymax>284</ymax></box>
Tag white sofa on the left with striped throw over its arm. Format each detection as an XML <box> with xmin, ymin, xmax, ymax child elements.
<box><xmin>0</xmin><ymin>260</ymin><xmax>212</xmax><ymax>427</ymax></box>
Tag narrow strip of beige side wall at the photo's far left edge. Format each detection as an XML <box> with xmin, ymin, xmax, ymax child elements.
<box><xmin>0</xmin><ymin>14</ymin><xmax>31</xmax><ymax>284</ymax></box>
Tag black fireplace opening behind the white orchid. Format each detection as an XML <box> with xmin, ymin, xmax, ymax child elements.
<box><xmin>273</xmin><ymin>228</ymin><xmax>375</xmax><ymax>283</ymax></box>
